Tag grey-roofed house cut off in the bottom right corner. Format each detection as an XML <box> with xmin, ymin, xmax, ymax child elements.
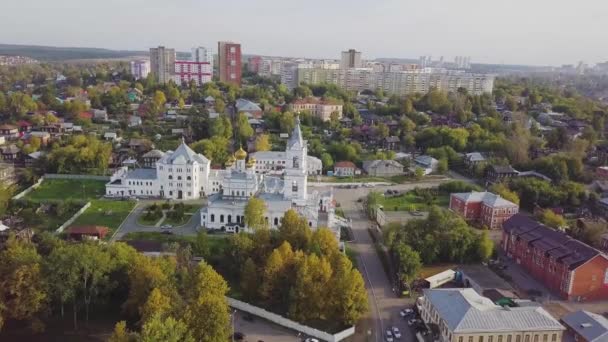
<box><xmin>562</xmin><ymin>310</ymin><xmax>608</xmax><ymax>342</ymax></box>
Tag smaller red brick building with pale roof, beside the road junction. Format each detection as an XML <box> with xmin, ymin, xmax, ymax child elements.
<box><xmin>450</xmin><ymin>191</ymin><xmax>519</xmax><ymax>229</ymax></box>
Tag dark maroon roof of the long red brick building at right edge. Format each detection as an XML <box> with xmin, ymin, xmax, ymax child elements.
<box><xmin>502</xmin><ymin>214</ymin><xmax>602</xmax><ymax>270</ymax></box>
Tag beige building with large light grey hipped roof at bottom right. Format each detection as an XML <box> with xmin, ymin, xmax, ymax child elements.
<box><xmin>421</xmin><ymin>288</ymin><xmax>565</xmax><ymax>342</ymax></box>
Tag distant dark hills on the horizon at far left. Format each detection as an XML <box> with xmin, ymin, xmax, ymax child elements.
<box><xmin>0</xmin><ymin>44</ymin><xmax>148</xmax><ymax>62</ymax></box>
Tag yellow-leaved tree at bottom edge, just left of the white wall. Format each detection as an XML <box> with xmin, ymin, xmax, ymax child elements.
<box><xmin>184</xmin><ymin>261</ymin><xmax>231</xmax><ymax>342</ymax></box>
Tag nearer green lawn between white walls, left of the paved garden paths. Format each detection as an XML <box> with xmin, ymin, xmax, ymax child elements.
<box><xmin>72</xmin><ymin>200</ymin><xmax>135</xmax><ymax>239</ymax></box>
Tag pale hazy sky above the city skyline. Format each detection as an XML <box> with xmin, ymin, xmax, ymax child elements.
<box><xmin>0</xmin><ymin>0</ymin><xmax>608</xmax><ymax>65</ymax></box>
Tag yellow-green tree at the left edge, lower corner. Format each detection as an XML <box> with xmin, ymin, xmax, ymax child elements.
<box><xmin>0</xmin><ymin>235</ymin><xmax>48</xmax><ymax>328</ymax></box>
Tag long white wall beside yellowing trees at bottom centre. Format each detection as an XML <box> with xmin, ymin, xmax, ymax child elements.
<box><xmin>226</xmin><ymin>297</ymin><xmax>355</xmax><ymax>342</ymax></box>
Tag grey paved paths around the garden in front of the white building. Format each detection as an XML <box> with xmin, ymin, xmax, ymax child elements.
<box><xmin>112</xmin><ymin>200</ymin><xmax>204</xmax><ymax>241</ymax></box>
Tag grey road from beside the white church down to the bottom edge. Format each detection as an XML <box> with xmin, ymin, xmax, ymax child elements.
<box><xmin>334</xmin><ymin>180</ymin><xmax>454</xmax><ymax>342</ymax></box>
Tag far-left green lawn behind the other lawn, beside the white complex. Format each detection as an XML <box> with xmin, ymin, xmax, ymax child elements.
<box><xmin>25</xmin><ymin>179</ymin><xmax>107</xmax><ymax>202</ymax></box>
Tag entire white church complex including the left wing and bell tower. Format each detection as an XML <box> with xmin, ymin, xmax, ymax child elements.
<box><xmin>106</xmin><ymin>120</ymin><xmax>337</xmax><ymax>232</ymax></box>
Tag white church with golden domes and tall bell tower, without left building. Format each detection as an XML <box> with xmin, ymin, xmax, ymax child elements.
<box><xmin>200</xmin><ymin>121</ymin><xmax>334</xmax><ymax>232</ymax></box>
